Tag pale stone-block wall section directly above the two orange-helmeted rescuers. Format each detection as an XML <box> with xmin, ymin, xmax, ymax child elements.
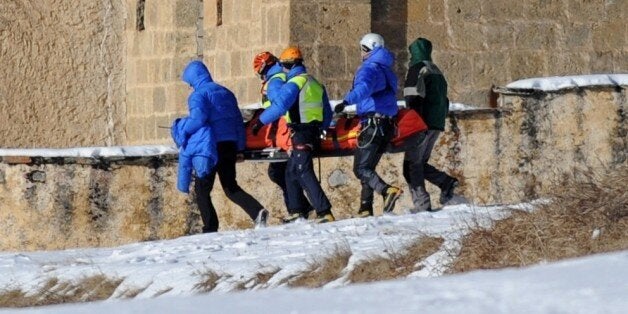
<box><xmin>203</xmin><ymin>0</ymin><xmax>290</xmax><ymax>105</ymax></box>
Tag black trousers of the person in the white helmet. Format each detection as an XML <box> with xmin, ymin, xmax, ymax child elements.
<box><xmin>353</xmin><ymin>119</ymin><xmax>395</xmax><ymax>211</ymax></box>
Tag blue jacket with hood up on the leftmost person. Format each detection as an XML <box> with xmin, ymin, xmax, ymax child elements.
<box><xmin>183</xmin><ymin>61</ymin><xmax>246</xmax><ymax>151</ymax></box>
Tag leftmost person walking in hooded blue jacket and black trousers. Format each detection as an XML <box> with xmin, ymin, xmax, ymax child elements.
<box><xmin>182</xmin><ymin>61</ymin><xmax>268</xmax><ymax>232</ymax></box>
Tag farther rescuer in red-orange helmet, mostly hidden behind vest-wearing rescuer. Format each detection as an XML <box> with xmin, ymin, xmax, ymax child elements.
<box><xmin>253</xmin><ymin>51</ymin><xmax>314</xmax><ymax>222</ymax></box>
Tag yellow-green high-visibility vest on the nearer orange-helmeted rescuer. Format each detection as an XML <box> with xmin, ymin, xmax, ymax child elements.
<box><xmin>286</xmin><ymin>73</ymin><xmax>325</xmax><ymax>123</ymax></box>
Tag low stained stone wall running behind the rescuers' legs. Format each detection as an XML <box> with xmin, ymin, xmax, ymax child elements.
<box><xmin>0</xmin><ymin>77</ymin><xmax>628</xmax><ymax>250</ymax></box>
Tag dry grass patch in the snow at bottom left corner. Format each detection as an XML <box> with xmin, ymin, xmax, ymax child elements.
<box><xmin>0</xmin><ymin>275</ymin><xmax>122</xmax><ymax>307</ymax></box>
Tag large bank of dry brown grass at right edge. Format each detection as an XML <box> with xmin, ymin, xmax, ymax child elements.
<box><xmin>451</xmin><ymin>165</ymin><xmax>628</xmax><ymax>273</ymax></box>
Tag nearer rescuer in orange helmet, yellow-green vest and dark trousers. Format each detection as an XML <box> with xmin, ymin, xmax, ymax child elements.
<box><xmin>253</xmin><ymin>47</ymin><xmax>335</xmax><ymax>223</ymax></box>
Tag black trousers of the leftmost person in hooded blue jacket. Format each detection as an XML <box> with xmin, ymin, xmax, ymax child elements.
<box><xmin>194</xmin><ymin>141</ymin><xmax>263</xmax><ymax>232</ymax></box>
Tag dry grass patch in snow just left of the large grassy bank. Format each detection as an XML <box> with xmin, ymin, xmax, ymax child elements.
<box><xmin>347</xmin><ymin>237</ymin><xmax>444</xmax><ymax>283</ymax></box>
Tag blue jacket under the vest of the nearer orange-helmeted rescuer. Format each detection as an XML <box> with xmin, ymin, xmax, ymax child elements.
<box><xmin>259</xmin><ymin>65</ymin><xmax>333</xmax><ymax>129</ymax></box>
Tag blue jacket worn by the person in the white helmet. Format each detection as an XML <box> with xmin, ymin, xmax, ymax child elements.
<box><xmin>344</xmin><ymin>47</ymin><xmax>399</xmax><ymax>116</ymax></box>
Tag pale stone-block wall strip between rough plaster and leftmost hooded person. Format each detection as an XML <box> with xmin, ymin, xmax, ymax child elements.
<box><xmin>123</xmin><ymin>0</ymin><xmax>203</xmax><ymax>145</ymax></box>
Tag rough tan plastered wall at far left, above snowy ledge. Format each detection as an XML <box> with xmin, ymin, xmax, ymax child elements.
<box><xmin>0</xmin><ymin>0</ymin><xmax>126</xmax><ymax>147</ymax></box>
